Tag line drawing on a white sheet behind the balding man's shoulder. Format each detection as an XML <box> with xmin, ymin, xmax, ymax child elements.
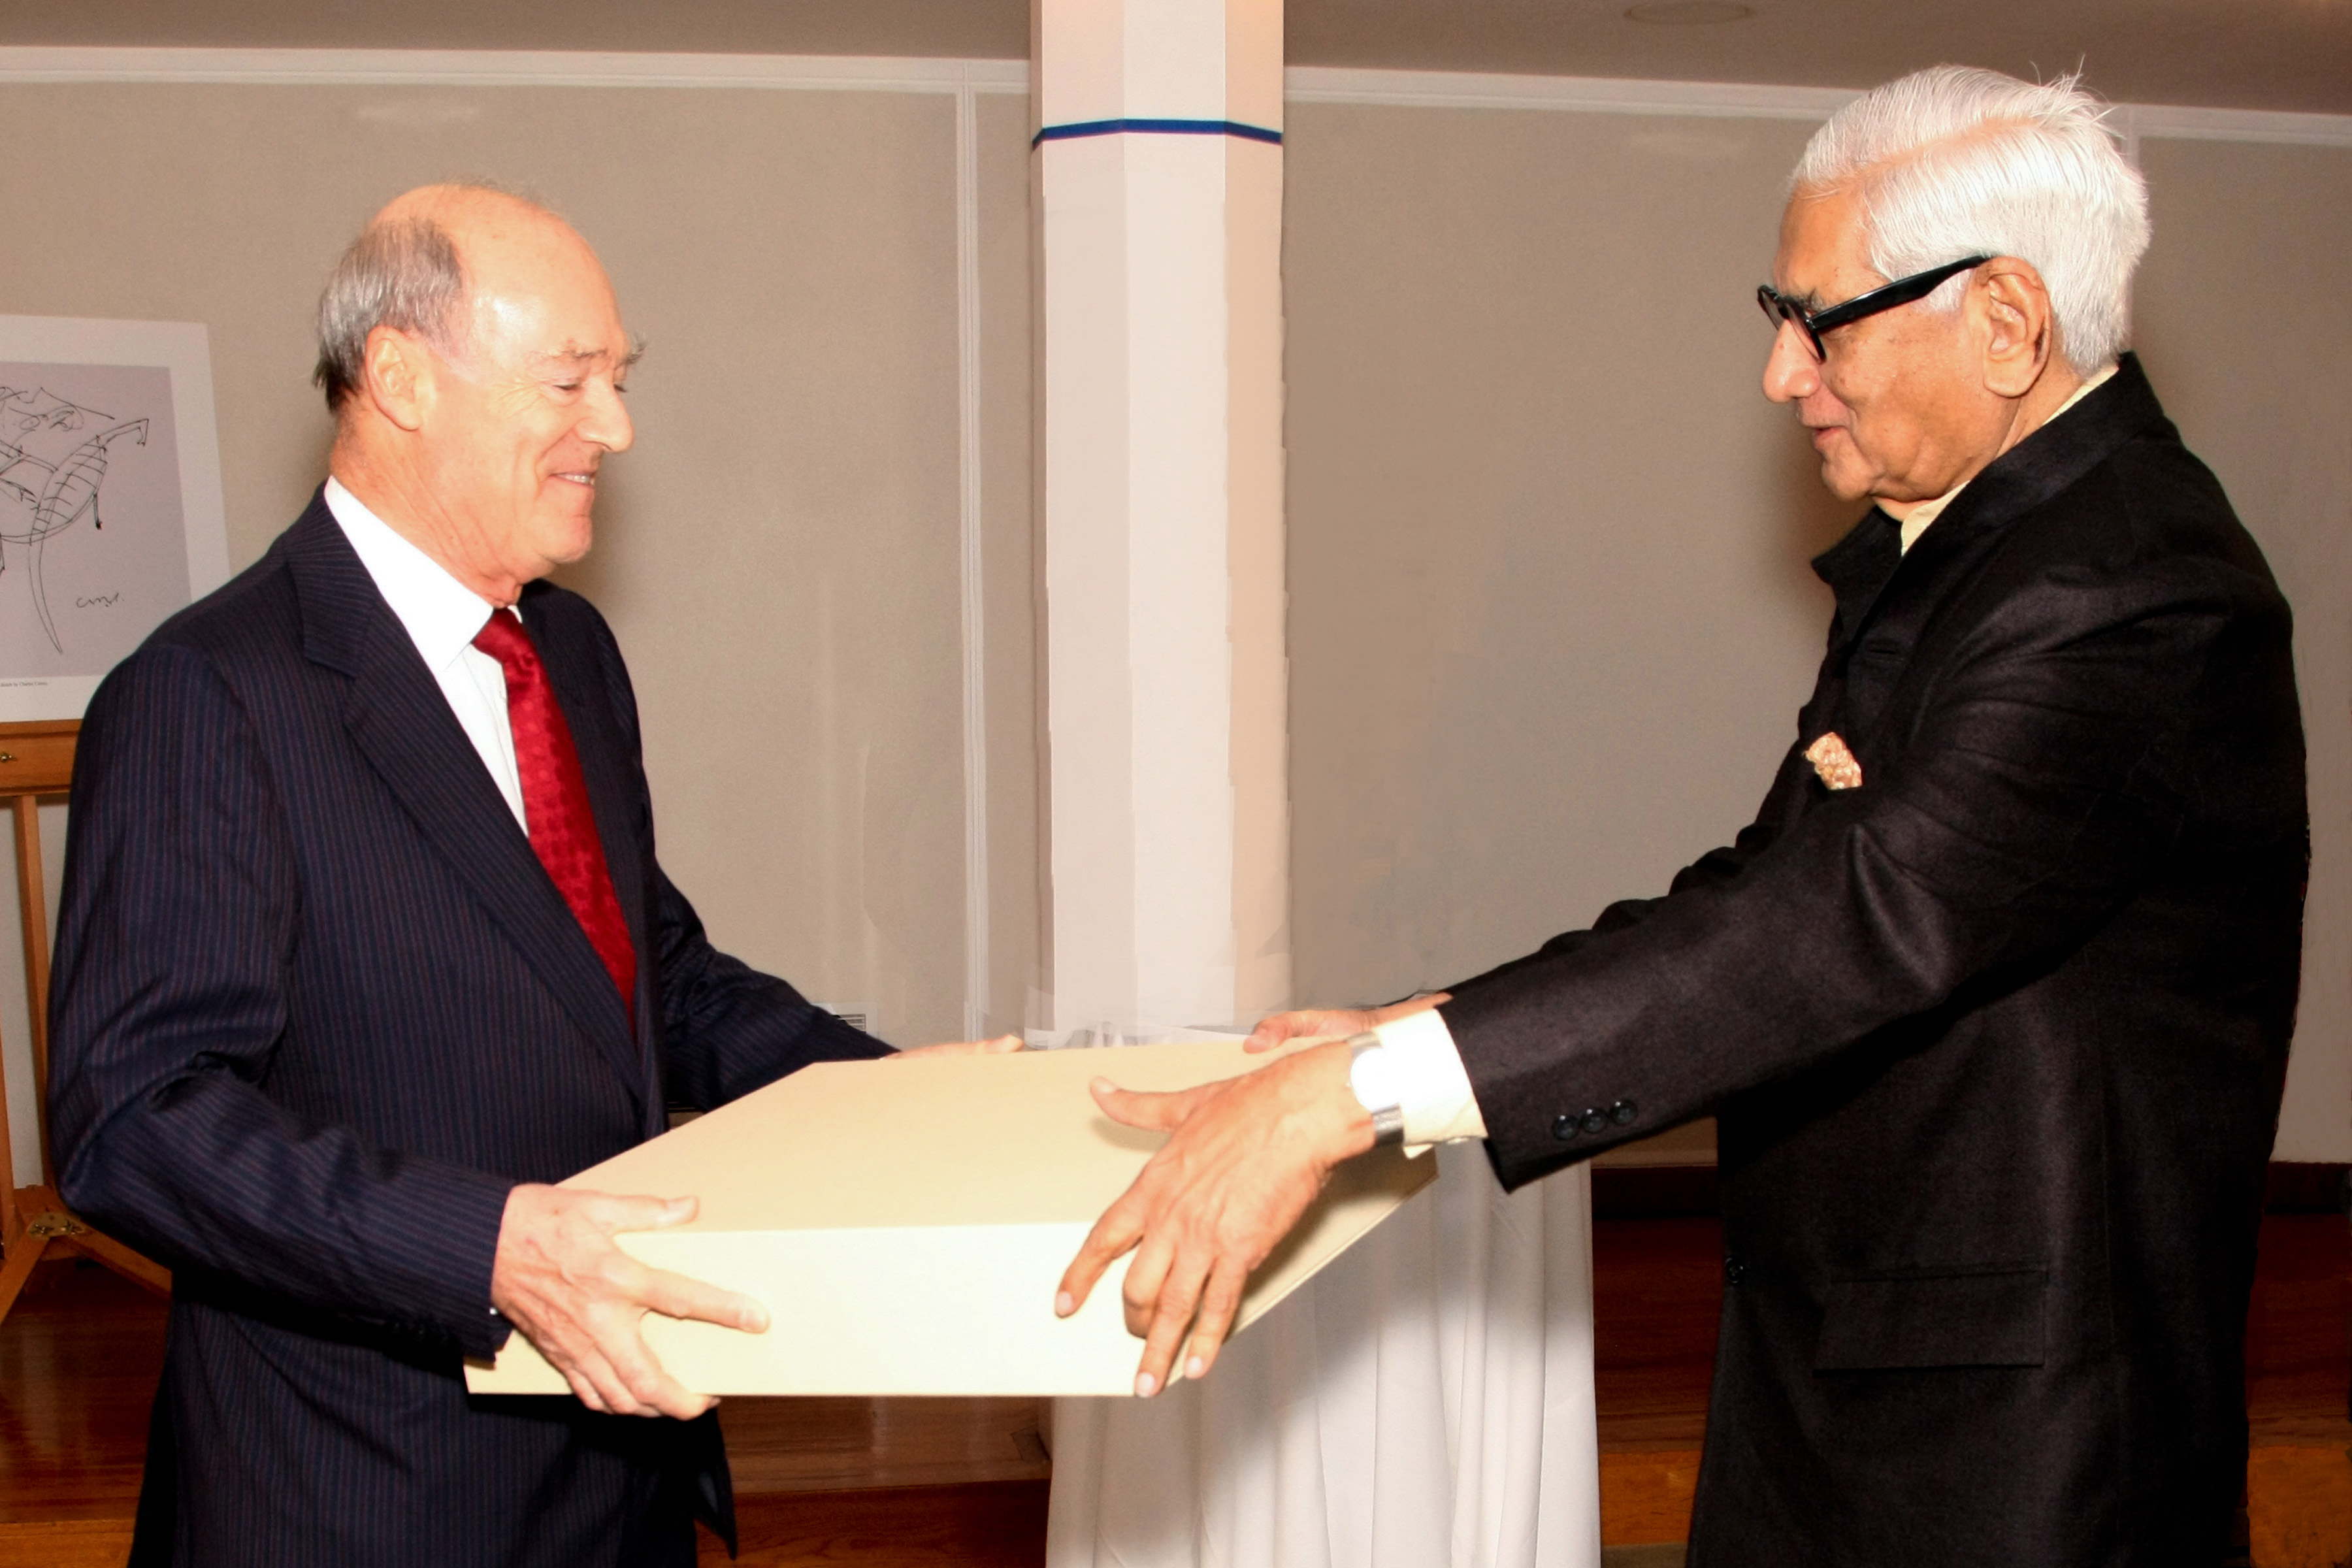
<box><xmin>0</xmin><ymin>315</ymin><xmax>228</xmax><ymax>722</ymax></box>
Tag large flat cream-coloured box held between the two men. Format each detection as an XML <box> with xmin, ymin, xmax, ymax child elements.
<box><xmin>466</xmin><ymin>1041</ymin><xmax>1437</xmax><ymax>1394</ymax></box>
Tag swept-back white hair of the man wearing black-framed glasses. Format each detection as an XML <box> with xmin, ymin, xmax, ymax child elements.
<box><xmin>1790</xmin><ymin>66</ymin><xmax>2148</xmax><ymax>374</ymax></box>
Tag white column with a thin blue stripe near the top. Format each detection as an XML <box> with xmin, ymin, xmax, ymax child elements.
<box><xmin>1032</xmin><ymin>0</ymin><xmax>1289</xmax><ymax>1030</ymax></box>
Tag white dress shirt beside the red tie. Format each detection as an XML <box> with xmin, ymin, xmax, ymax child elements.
<box><xmin>327</xmin><ymin>480</ymin><xmax>532</xmax><ymax>834</ymax></box>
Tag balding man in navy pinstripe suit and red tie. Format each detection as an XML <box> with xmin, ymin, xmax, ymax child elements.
<box><xmin>50</xmin><ymin>186</ymin><xmax>1004</xmax><ymax>1568</ymax></box>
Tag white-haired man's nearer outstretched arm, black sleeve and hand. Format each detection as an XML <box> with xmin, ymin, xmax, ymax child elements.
<box><xmin>1056</xmin><ymin>562</ymin><xmax>2298</xmax><ymax>1392</ymax></box>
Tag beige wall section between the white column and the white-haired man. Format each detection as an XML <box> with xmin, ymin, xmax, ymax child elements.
<box><xmin>1286</xmin><ymin>106</ymin><xmax>1851</xmax><ymax>999</ymax></box>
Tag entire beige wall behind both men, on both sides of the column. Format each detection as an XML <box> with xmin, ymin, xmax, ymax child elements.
<box><xmin>0</xmin><ymin>70</ymin><xmax>2352</xmax><ymax>1189</ymax></box>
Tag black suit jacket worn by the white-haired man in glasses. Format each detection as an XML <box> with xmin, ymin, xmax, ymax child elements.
<box><xmin>1444</xmin><ymin>357</ymin><xmax>2308</xmax><ymax>1568</ymax></box>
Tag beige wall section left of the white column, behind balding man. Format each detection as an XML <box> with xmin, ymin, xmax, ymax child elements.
<box><xmin>0</xmin><ymin>85</ymin><xmax>1035</xmax><ymax>1189</ymax></box>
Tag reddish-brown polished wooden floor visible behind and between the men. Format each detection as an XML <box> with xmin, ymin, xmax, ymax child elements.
<box><xmin>0</xmin><ymin>1215</ymin><xmax>2352</xmax><ymax>1568</ymax></box>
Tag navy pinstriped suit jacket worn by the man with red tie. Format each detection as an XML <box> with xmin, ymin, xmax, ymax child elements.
<box><xmin>50</xmin><ymin>498</ymin><xmax>885</xmax><ymax>1568</ymax></box>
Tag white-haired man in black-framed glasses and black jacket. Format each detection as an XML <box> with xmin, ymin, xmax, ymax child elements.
<box><xmin>1061</xmin><ymin>68</ymin><xmax>2308</xmax><ymax>1568</ymax></box>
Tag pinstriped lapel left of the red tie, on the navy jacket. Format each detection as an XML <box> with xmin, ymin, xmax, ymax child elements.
<box><xmin>287</xmin><ymin>498</ymin><xmax>649</xmax><ymax>1100</ymax></box>
